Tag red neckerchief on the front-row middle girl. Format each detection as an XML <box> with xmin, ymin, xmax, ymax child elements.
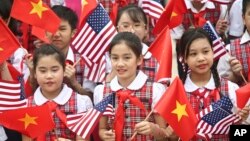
<box><xmin>114</xmin><ymin>90</ymin><xmax>146</xmax><ymax>141</ymax></box>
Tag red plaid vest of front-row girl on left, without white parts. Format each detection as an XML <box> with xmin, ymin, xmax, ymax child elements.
<box><xmin>28</xmin><ymin>92</ymin><xmax>77</xmax><ymax>141</ymax></box>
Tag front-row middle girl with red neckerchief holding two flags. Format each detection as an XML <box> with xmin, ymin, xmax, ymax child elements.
<box><xmin>94</xmin><ymin>32</ymin><xmax>174</xmax><ymax>141</ymax></box>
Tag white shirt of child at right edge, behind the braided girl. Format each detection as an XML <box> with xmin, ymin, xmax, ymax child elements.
<box><xmin>217</xmin><ymin>30</ymin><xmax>250</xmax><ymax>77</ymax></box>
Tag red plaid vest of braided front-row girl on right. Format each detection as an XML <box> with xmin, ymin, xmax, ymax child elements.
<box><xmin>187</xmin><ymin>78</ymin><xmax>229</xmax><ymax>141</ymax></box>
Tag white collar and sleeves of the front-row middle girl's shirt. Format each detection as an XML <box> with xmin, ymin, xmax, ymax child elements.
<box><xmin>94</xmin><ymin>71</ymin><xmax>166</xmax><ymax>108</ymax></box>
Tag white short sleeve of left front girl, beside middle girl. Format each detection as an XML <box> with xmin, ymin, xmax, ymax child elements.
<box><xmin>77</xmin><ymin>94</ymin><xmax>93</xmax><ymax>113</ymax></box>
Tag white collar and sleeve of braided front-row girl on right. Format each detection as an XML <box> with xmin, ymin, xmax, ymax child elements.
<box><xmin>184</xmin><ymin>74</ymin><xmax>250</xmax><ymax>124</ymax></box>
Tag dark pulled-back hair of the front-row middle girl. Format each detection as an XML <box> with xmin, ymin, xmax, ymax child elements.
<box><xmin>109</xmin><ymin>32</ymin><xmax>142</xmax><ymax>58</ymax></box>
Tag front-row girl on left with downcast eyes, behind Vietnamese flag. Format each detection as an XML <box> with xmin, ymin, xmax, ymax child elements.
<box><xmin>23</xmin><ymin>44</ymin><xmax>92</xmax><ymax>140</ymax></box>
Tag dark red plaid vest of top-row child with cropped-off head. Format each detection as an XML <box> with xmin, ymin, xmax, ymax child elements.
<box><xmin>182</xmin><ymin>3</ymin><xmax>221</xmax><ymax>30</ymax></box>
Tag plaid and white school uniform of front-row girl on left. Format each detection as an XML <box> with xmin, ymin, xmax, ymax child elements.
<box><xmin>28</xmin><ymin>84</ymin><xmax>93</xmax><ymax>141</ymax></box>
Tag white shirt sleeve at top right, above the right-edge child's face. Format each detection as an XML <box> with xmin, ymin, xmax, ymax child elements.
<box><xmin>229</xmin><ymin>0</ymin><xmax>244</xmax><ymax>37</ymax></box>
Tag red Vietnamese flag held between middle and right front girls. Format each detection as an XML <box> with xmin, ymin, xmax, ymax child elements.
<box><xmin>154</xmin><ymin>77</ymin><xmax>198</xmax><ymax>141</ymax></box>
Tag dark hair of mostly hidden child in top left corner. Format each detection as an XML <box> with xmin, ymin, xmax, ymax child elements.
<box><xmin>0</xmin><ymin>0</ymin><xmax>21</xmax><ymax>35</ymax></box>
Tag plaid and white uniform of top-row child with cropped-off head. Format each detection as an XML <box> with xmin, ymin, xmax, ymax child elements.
<box><xmin>171</xmin><ymin>0</ymin><xmax>227</xmax><ymax>39</ymax></box>
